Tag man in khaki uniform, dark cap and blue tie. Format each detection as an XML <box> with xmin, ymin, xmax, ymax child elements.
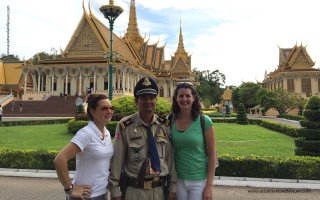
<box><xmin>109</xmin><ymin>77</ymin><xmax>175</xmax><ymax>200</ymax></box>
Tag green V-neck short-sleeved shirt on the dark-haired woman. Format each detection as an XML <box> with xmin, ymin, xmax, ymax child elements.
<box><xmin>172</xmin><ymin>115</ymin><xmax>213</xmax><ymax>180</ymax></box>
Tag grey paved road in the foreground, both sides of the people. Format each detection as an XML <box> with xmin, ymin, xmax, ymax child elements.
<box><xmin>0</xmin><ymin>176</ymin><xmax>320</xmax><ymax>200</ymax></box>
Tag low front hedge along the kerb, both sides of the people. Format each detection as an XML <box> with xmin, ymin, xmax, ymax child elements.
<box><xmin>0</xmin><ymin>150</ymin><xmax>320</xmax><ymax>180</ymax></box>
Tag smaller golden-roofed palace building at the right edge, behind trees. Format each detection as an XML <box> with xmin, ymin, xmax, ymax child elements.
<box><xmin>263</xmin><ymin>45</ymin><xmax>320</xmax><ymax>98</ymax></box>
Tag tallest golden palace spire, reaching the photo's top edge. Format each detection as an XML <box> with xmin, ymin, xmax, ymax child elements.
<box><xmin>126</xmin><ymin>0</ymin><xmax>142</xmax><ymax>39</ymax></box>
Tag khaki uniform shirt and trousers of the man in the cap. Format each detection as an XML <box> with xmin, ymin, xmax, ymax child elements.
<box><xmin>109</xmin><ymin>113</ymin><xmax>176</xmax><ymax>200</ymax></box>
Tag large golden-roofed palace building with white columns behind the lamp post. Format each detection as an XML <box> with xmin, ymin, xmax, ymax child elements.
<box><xmin>21</xmin><ymin>0</ymin><xmax>196</xmax><ymax>100</ymax></box>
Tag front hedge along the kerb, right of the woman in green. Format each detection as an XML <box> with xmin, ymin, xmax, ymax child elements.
<box><xmin>216</xmin><ymin>155</ymin><xmax>320</xmax><ymax>180</ymax></box>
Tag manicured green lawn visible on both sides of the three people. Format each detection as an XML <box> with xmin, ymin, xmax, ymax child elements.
<box><xmin>0</xmin><ymin>123</ymin><xmax>295</xmax><ymax>156</ymax></box>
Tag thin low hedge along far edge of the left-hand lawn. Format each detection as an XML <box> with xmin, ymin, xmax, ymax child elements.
<box><xmin>0</xmin><ymin>118</ymin><xmax>70</xmax><ymax>127</ymax></box>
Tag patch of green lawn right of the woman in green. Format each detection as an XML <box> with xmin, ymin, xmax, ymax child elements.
<box><xmin>214</xmin><ymin>123</ymin><xmax>295</xmax><ymax>156</ymax></box>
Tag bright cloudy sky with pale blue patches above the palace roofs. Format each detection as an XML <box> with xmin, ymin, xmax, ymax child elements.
<box><xmin>0</xmin><ymin>0</ymin><xmax>320</xmax><ymax>86</ymax></box>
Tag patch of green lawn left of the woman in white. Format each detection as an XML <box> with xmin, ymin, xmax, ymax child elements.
<box><xmin>0</xmin><ymin>124</ymin><xmax>73</xmax><ymax>150</ymax></box>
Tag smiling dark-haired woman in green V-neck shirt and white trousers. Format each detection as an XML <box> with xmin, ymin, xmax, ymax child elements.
<box><xmin>171</xmin><ymin>82</ymin><xmax>216</xmax><ymax>200</ymax></box>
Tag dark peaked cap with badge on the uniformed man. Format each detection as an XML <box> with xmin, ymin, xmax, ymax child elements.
<box><xmin>134</xmin><ymin>77</ymin><xmax>158</xmax><ymax>97</ymax></box>
